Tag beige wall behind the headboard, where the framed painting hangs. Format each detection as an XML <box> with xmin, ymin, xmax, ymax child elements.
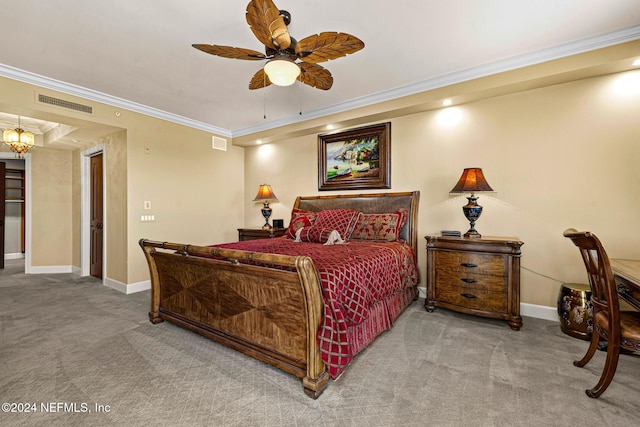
<box><xmin>245</xmin><ymin>71</ymin><xmax>640</xmax><ymax>307</ymax></box>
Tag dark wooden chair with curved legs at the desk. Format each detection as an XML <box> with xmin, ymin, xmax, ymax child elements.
<box><xmin>563</xmin><ymin>228</ymin><xmax>640</xmax><ymax>398</ymax></box>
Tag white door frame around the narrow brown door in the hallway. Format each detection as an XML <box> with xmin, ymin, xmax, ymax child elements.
<box><xmin>80</xmin><ymin>144</ymin><xmax>107</xmax><ymax>285</ymax></box>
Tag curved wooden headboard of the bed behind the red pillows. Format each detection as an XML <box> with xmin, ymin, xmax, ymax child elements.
<box><xmin>293</xmin><ymin>191</ymin><xmax>420</xmax><ymax>254</ymax></box>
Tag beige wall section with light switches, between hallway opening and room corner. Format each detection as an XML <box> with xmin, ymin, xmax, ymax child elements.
<box><xmin>127</xmin><ymin>120</ymin><xmax>245</xmax><ymax>283</ymax></box>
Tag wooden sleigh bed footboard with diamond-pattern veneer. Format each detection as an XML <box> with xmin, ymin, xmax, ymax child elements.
<box><xmin>139</xmin><ymin>239</ymin><xmax>329</xmax><ymax>399</ymax></box>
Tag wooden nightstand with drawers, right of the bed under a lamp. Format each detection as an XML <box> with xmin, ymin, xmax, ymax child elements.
<box><xmin>424</xmin><ymin>236</ymin><xmax>523</xmax><ymax>331</ymax></box>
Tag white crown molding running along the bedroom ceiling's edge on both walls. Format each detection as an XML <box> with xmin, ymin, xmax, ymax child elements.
<box><xmin>0</xmin><ymin>25</ymin><xmax>640</xmax><ymax>138</ymax></box>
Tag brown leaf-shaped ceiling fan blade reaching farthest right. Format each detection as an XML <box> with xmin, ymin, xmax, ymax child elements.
<box><xmin>296</xmin><ymin>31</ymin><xmax>364</xmax><ymax>63</ymax></box>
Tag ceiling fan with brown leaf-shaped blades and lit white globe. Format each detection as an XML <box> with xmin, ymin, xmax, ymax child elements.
<box><xmin>193</xmin><ymin>0</ymin><xmax>364</xmax><ymax>90</ymax></box>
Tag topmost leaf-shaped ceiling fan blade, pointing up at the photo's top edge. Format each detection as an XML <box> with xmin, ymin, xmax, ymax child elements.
<box><xmin>247</xmin><ymin>0</ymin><xmax>291</xmax><ymax>50</ymax></box>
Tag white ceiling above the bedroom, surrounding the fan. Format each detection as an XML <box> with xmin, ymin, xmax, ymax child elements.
<box><xmin>0</xmin><ymin>0</ymin><xmax>640</xmax><ymax>141</ymax></box>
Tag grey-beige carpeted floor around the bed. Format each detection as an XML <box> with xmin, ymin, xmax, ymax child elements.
<box><xmin>0</xmin><ymin>260</ymin><xmax>640</xmax><ymax>427</ymax></box>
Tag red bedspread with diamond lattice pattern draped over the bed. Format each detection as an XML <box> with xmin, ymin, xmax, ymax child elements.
<box><xmin>215</xmin><ymin>237</ymin><xmax>418</xmax><ymax>378</ymax></box>
